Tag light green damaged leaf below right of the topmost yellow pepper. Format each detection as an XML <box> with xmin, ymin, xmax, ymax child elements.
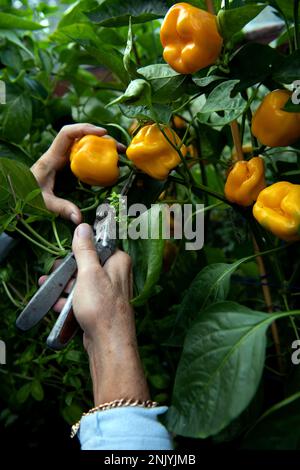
<box><xmin>197</xmin><ymin>80</ymin><xmax>246</xmax><ymax>126</ymax></box>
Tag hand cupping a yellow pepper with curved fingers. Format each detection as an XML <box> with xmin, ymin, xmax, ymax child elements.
<box><xmin>31</xmin><ymin>123</ymin><xmax>126</xmax><ymax>224</ymax></box>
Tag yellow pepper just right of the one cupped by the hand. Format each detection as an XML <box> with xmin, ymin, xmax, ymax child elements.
<box><xmin>126</xmin><ymin>124</ymin><xmax>187</xmax><ymax>180</ymax></box>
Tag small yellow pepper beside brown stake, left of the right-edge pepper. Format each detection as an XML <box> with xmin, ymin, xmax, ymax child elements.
<box><xmin>225</xmin><ymin>157</ymin><xmax>266</xmax><ymax>207</ymax></box>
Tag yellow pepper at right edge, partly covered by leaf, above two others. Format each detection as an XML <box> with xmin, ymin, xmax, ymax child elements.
<box><xmin>251</xmin><ymin>90</ymin><xmax>300</xmax><ymax>147</ymax></box>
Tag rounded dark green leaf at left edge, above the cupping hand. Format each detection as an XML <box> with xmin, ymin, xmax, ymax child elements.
<box><xmin>2</xmin><ymin>93</ymin><xmax>32</xmax><ymax>143</ymax></box>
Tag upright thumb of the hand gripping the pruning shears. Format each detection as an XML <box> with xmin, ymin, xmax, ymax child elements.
<box><xmin>72</xmin><ymin>224</ymin><xmax>101</xmax><ymax>274</ymax></box>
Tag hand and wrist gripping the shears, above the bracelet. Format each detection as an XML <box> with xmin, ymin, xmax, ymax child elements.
<box><xmin>39</xmin><ymin>224</ymin><xmax>149</xmax><ymax>406</ymax></box>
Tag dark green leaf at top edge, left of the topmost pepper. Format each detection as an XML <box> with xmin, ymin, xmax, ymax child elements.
<box><xmin>86</xmin><ymin>0</ymin><xmax>168</xmax><ymax>26</ymax></box>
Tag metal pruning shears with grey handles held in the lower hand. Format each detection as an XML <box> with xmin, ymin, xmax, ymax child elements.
<box><xmin>16</xmin><ymin>172</ymin><xmax>135</xmax><ymax>350</ymax></box>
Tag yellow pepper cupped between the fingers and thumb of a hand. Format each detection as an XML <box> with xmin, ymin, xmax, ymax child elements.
<box><xmin>70</xmin><ymin>135</ymin><xmax>119</xmax><ymax>186</ymax></box>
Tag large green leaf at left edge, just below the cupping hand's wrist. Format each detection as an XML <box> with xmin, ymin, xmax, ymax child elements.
<box><xmin>0</xmin><ymin>158</ymin><xmax>52</xmax><ymax>218</ymax></box>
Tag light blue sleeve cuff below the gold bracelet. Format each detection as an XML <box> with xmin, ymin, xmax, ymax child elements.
<box><xmin>78</xmin><ymin>406</ymin><xmax>173</xmax><ymax>450</ymax></box>
